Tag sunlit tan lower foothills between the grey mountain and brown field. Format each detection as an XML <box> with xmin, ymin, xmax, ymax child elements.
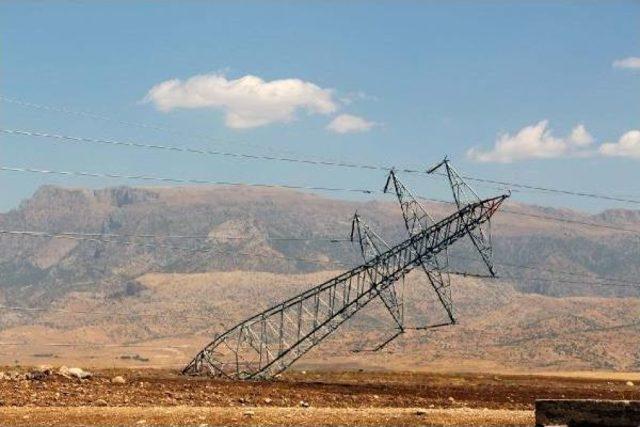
<box><xmin>0</xmin><ymin>271</ymin><xmax>640</xmax><ymax>371</ymax></box>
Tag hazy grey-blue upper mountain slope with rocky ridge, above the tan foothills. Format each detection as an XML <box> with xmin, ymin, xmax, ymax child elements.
<box><xmin>0</xmin><ymin>186</ymin><xmax>640</xmax><ymax>304</ymax></box>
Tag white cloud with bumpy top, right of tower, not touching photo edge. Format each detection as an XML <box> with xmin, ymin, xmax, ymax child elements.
<box><xmin>467</xmin><ymin>120</ymin><xmax>593</xmax><ymax>163</ymax></box>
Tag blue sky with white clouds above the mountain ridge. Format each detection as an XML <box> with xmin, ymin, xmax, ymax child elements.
<box><xmin>0</xmin><ymin>0</ymin><xmax>640</xmax><ymax>212</ymax></box>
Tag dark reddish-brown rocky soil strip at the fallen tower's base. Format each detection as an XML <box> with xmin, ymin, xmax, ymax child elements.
<box><xmin>0</xmin><ymin>367</ymin><xmax>640</xmax><ymax>410</ymax></box>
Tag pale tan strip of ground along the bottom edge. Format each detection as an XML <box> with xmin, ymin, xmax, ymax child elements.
<box><xmin>0</xmin><ymin>406</ymin><xmax>534</xmax><ymax>427</ymax></box>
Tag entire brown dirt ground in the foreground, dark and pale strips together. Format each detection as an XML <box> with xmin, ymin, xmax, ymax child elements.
<box><xmin>0</xmin><ymin>367</ymin><xmax>640</xmax><ymax>425</ymax></box>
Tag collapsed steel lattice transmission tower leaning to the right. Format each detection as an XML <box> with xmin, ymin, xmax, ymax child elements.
<box><xmin>182</xmin><ymin>159</ymin><xmax>509</xmax><ymax>379</ymax></box>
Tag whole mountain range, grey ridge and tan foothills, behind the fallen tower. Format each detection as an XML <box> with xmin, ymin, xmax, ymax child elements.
<box><xmin>0</xmin><ymin>186</ymin><xmax>640</xmax><ymax>370</ymax></box>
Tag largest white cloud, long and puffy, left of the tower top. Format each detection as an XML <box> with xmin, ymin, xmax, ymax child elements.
<box><xmin>145</xmin><ymin>74</ymin><xmax>338</xmax><ymax>129</ymax></box>
